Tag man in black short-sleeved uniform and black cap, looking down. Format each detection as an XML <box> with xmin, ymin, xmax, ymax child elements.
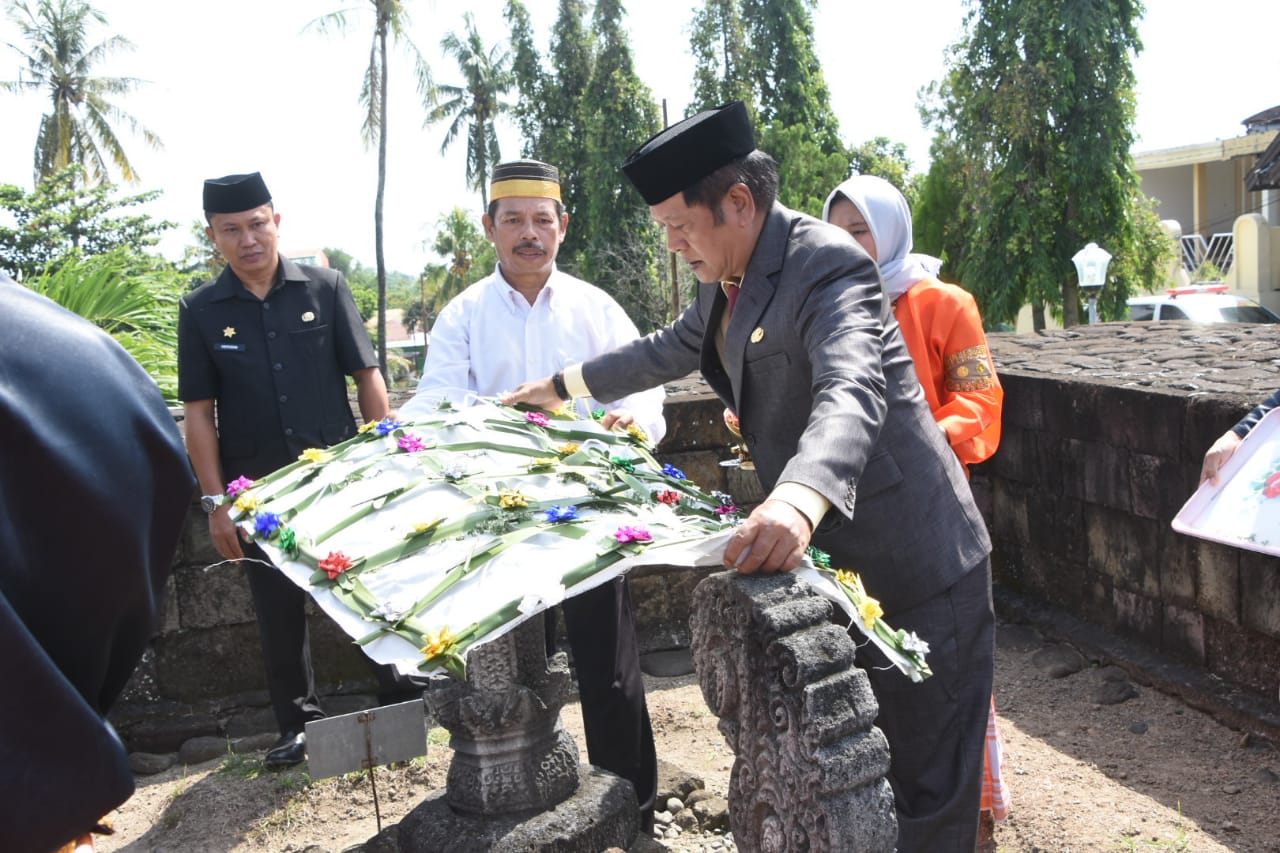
<box><xmin>178</xmin><ymin>172</ymin><xmax>389</xmax><ymax>767</ymax></box>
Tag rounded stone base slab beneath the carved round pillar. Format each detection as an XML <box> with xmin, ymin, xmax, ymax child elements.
<box><xmin>364</xmin><ymin>765</ymin><xmax>640</xmax><ymax>853</ymax></box>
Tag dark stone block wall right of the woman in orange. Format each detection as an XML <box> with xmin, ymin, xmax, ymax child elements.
<box><xmin>973</xmin><ymin>323</ymin><xmax>1280</xmax><ymax>697</ymax></box>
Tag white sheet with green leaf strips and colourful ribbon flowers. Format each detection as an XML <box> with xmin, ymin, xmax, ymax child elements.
<box><xmin>205</xmin><ymin>400</ymin><xmax>928</xmax><ymax>679</ymax></box>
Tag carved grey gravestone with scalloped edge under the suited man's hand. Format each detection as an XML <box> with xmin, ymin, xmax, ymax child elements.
<box><xmin>691</xmin><ymin>571</ymin><xmax>897</xmax><ymax>853</ymax></box>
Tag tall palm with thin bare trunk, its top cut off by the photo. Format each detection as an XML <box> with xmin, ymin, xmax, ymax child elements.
<box><xmin>306</xmin><ymin>0</ymin><xmax>435</xmax><ymax>378</ymax></box>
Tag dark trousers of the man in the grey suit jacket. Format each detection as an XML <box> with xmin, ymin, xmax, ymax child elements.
<box><xmin>855</xmin><ymin>560</ymin><xmax>996</xmax><ymax>853</ymax></box>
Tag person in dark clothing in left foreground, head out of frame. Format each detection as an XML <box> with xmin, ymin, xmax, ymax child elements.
<box><xmin>0</xmin><ymin>273</ymin><xmax>196</xmax><ymax>850</ymax></box>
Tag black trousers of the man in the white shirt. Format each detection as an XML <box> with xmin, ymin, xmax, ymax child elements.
<box><xmin>547</xmin><ymin>578</ymin><xmax>658</xmax><ymax>830</ymax></box>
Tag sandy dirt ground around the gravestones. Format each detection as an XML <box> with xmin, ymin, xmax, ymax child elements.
<box><xmin>97</xmin><ymin>622</ymin><xmax>1280</xmax><ymax>853</ymax></box>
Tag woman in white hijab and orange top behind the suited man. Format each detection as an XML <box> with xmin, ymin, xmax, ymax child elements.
<box><xmin>822</xmin><ymin>174</ymin><xmax>1009</xmax><ymax>835</ymax></box>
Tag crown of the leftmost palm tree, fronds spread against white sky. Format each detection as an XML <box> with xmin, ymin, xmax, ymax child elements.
<box><xmin>0</xmin><ymin>0</ymin><xmax>161</xmax><ymax>183</ymax></box>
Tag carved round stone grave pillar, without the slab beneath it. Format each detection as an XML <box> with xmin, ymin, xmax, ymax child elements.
<box><xmin>424</xmin><ymin>619</ymin><xmax>579</xmax><ymax>815</ymax></box>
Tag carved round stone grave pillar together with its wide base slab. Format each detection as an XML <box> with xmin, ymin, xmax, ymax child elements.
<box><xmin>373</xmin><ymin>617</ymin><xmax>640</xmax><ymax>853</ymax></box>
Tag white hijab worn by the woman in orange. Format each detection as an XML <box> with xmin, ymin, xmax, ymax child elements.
<box><xmin>822</xmin><ymin>174</ymin><xmax>942</xmax><ymax>302</ymax></box>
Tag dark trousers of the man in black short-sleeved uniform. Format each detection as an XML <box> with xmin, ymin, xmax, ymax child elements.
<box><xmin>241</xmin><ymin>543</ymin><xmax>425</xmax><ymax>735</ymax></box>
